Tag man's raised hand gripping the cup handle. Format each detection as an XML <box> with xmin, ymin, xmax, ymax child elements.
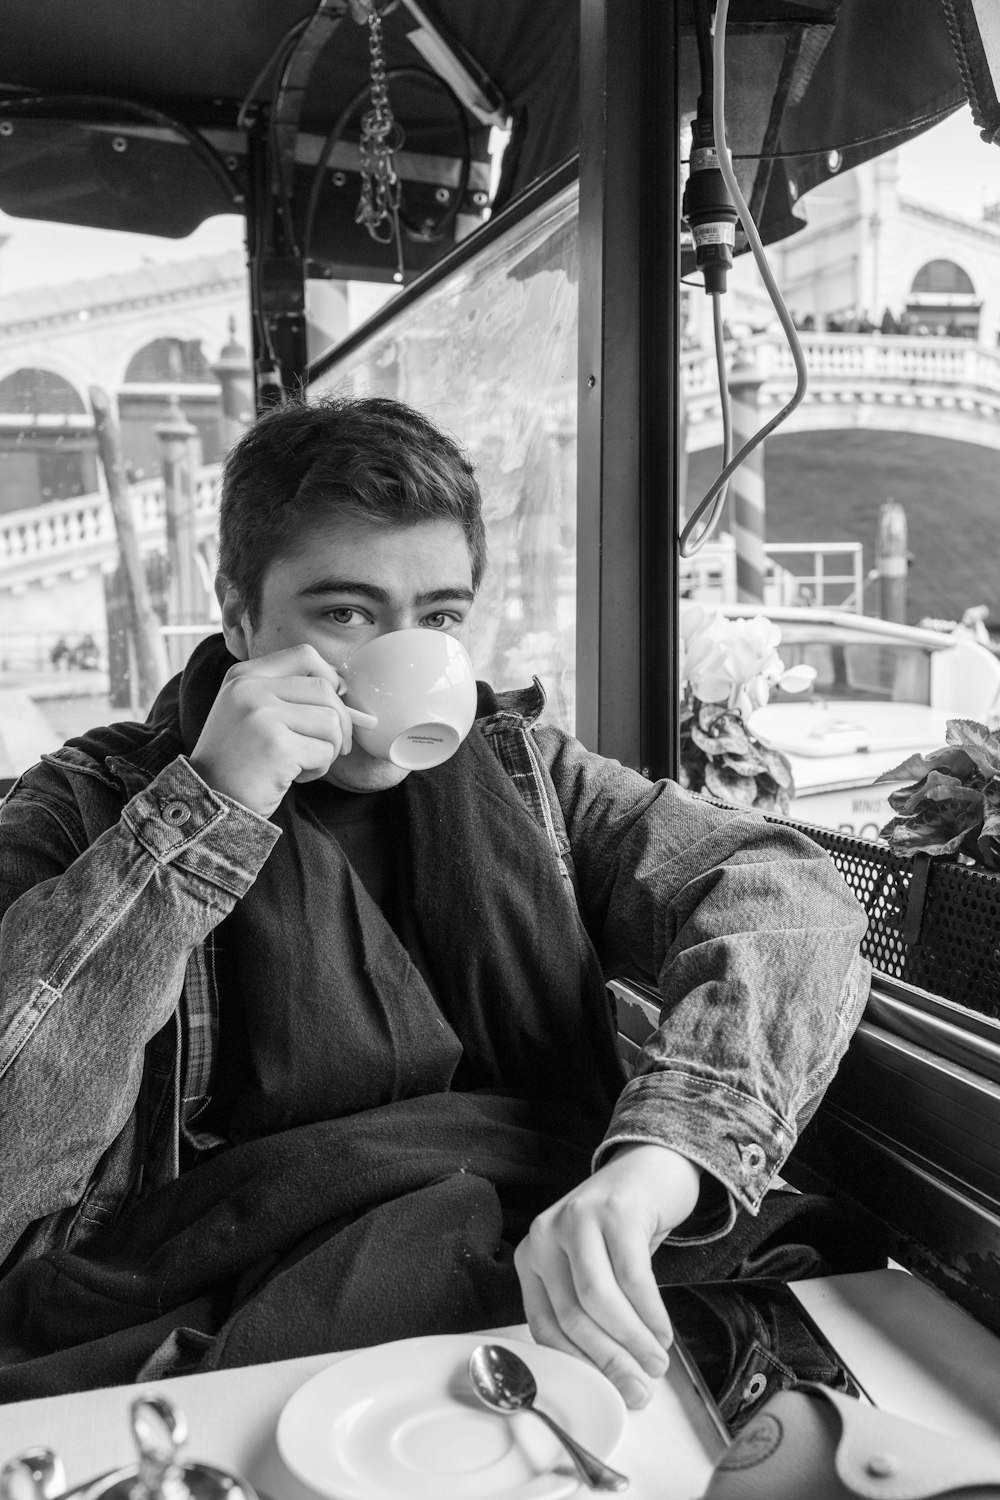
<box><xmin>190</xmin><ymin>645</ymin><xmax>372</xmax><ymax>818</ymax></box>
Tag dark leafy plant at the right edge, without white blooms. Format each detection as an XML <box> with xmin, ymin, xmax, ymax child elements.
<box><xmin>876</xmin><ymin>719</ymin><xmax>1000</xmax><ymax>870</ymax></box>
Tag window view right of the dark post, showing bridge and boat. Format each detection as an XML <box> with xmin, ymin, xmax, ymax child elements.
<box><xmin>681</xmin><ymin>110</ymin><xmax>1000</xmax><ymax>839</ymax></box>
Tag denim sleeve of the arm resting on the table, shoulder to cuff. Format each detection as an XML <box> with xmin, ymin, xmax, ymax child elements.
<box><xmin>535</xmin><ymin>728</ymin><xmax>871</xmax><ymax>1239</ymax></box>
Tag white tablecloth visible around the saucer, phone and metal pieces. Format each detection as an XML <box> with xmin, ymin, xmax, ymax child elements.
<box><xmin>7</xmin><ymin>1271</ymin><xmax>1000</xmax><ymax>1500</ymax></box>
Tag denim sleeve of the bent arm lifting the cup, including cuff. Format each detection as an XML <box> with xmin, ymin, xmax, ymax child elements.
<box><xmin>0</xmin><ymin>753</ymin><xmax>279</xmax><ymax>1262</ymax></box>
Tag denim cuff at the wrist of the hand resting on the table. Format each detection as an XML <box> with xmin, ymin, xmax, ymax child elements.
<box><xmin>594</xmin><ymin>1068</ymin><xmax>795</xmax><ymax>1224</ymax></box>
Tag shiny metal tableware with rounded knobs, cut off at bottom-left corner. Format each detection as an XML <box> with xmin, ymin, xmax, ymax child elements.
<box><xmin>0</xmin><ymin>1392</ymin><xmax>262</xmax><ymax>1500</ymax></box>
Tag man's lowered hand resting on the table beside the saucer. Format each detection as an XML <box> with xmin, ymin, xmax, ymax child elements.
<box><xmin>514</xmin><ymin>1145</ymin><xmax>700</xmax><ymax>1407</ymax></box>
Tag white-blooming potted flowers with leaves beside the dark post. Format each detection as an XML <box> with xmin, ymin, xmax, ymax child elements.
<box><xmin>679</xmin><ymin>603</ymin><xmax>816</xmax><ymax>815</ymax></box>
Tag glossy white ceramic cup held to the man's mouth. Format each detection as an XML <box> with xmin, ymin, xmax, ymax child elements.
<box><xmin>337</xmin><ymin>630</ymin><xmax>477</xmax><ymax>771</ymax></box>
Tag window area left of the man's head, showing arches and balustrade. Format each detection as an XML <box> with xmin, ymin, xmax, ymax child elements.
<box><xmin>0</xmin><ymin>216</ymin><xmax>252</xmax><ymax>789</ymax></box>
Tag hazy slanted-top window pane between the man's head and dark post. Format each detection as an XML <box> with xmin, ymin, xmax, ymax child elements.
<box><xmin>312</xmin><ymin>188</ymin><xmax>577</xmax><ymax>729</ymax></box>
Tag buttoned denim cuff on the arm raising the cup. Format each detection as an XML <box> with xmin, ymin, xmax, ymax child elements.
<box><xmin>121</xmin><ymin>755</ymin><xmax>280</xmax><ymax>899</ymax></box>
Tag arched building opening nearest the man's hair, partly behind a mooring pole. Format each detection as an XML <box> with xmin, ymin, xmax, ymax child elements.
<box><xmin>118</xmin><ymin>338</ymin><xmax>220</xmax><ymax>479</ymax></box>
